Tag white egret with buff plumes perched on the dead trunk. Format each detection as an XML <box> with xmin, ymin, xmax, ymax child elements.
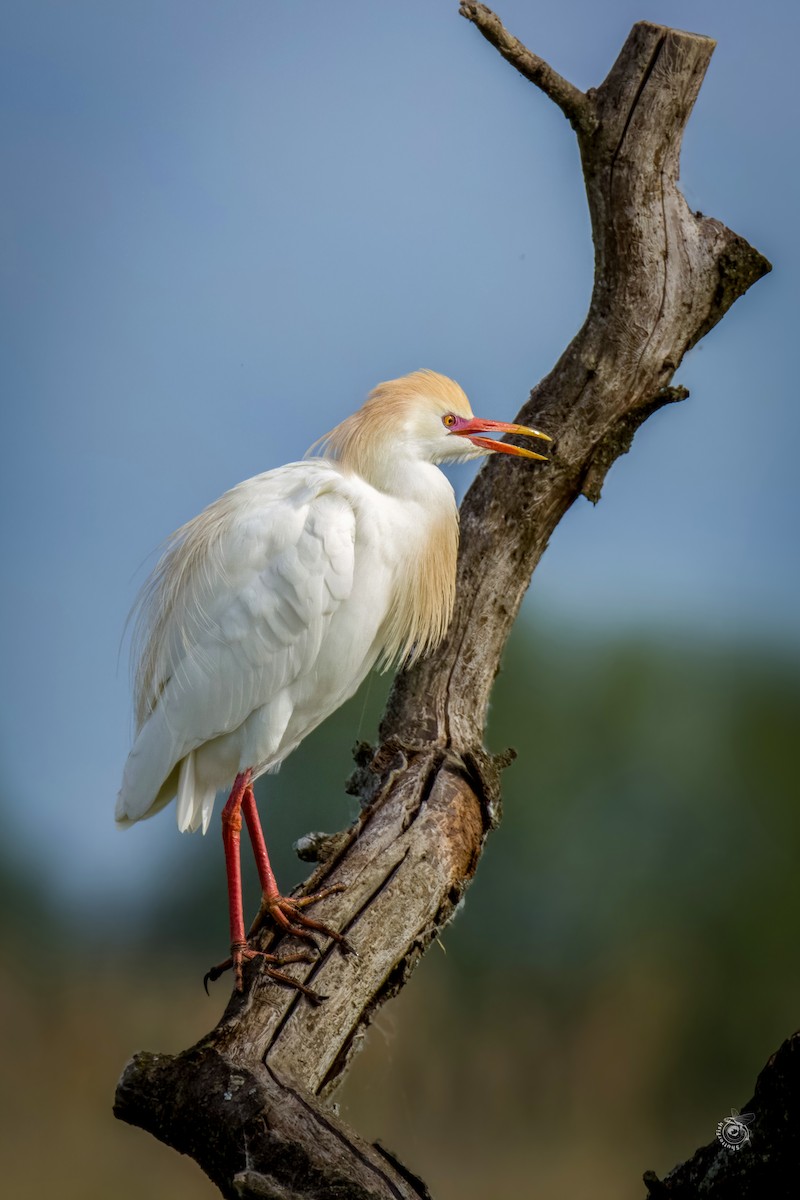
<box><xmin>116</xmin><ymin>371</ymin><xmax>549</xmax><ymax>990</ymax></box>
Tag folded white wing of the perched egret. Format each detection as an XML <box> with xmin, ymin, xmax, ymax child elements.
<box><xmin>116</xmin><ymin>462</ymin><xmax>355</xmax><ymax>823</ymax></box>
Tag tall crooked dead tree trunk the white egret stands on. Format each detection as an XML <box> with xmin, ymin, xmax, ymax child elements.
<box><xmin>115</xmin><ymin>4</ymin><xmax>770</xmax><ymax>1198</ymax></box>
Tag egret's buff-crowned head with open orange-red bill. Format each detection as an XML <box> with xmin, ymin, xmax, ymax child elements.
<box><xmin>312</xmin><ymin>371</ymin><xmax>551</xmax><ymax>481</ymax></box>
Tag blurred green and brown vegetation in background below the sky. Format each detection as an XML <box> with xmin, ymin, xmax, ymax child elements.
<box><xmin>0</xmin><ymin>623</ymin><xmax>800</xmax><ymax>1200</ymax></box>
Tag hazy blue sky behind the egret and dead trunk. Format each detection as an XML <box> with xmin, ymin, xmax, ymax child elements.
<box><xmin>0</xmin><ymin>0</ymin><xmax>800</xmax><ymax>899</ymax></box>
